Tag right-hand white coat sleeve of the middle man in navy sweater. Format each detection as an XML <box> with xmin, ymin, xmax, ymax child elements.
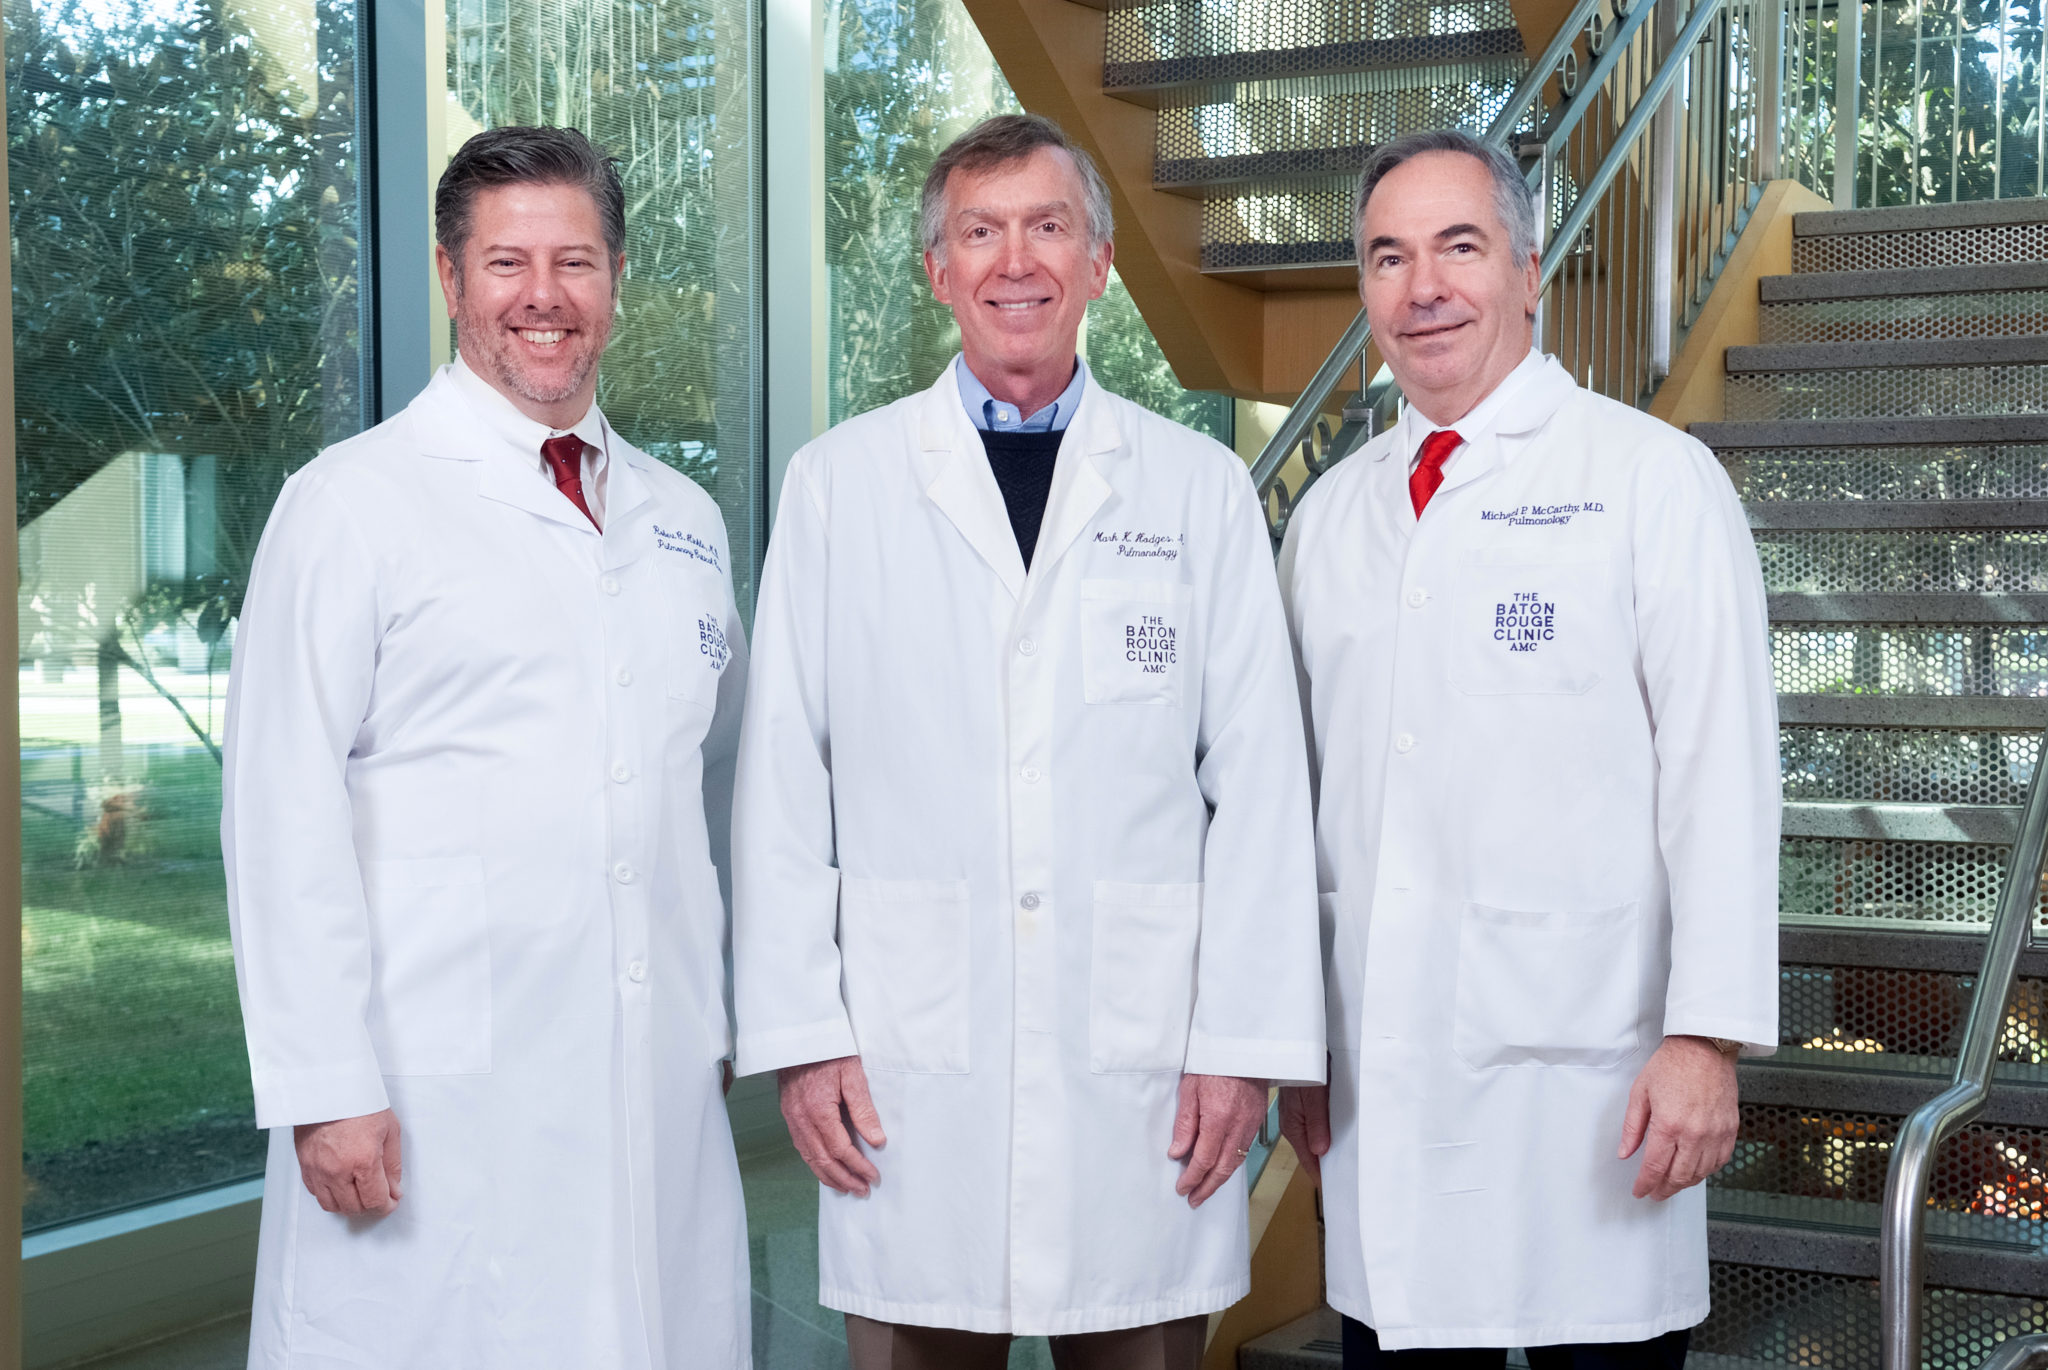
<box><xmin>1184</xmin><ymin>464</ymin><xmax>1327</xmax><ymax>1083</ymax></box>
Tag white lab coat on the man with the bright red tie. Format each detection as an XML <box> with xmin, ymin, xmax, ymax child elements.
<box><xmin>1280</xmin><ymin>356</ymin><xmax>1778</xmax><ymax>1350</ymax></box>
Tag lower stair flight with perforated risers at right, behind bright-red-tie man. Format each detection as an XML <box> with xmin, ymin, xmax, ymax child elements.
<box><xmin>1239</xmin><ymin>199</ymin><xmax>2048</xmax><ymax>1370</ymax></box>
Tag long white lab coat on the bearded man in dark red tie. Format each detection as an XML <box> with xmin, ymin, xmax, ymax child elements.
<box><xmin>221</xmin><ymin>369</ymin><xmax>750</xmax><ymax>1370</ymax></box>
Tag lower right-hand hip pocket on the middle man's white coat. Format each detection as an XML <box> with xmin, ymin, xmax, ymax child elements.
<box><xmin>1087</xmin><ymin>881</ymin><xmax>1202</xmax><ymax>1075</ymax></box>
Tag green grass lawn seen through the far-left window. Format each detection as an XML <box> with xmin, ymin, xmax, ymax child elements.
<box><xmin>23</xmin><ymin>739</ymin><xmax>250</xmax><ymax>1206</ymax></box>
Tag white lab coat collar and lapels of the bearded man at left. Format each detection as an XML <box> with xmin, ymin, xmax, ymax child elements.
<box><xmin>406</xmin><ymin>360</ymin><xmax>653</xmax><ymax>567</ymax></box>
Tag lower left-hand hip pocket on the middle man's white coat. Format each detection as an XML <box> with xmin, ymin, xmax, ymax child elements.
<box><xmin>840</xmin><ymin>876</ymin><xmax>969</xmax><ymax>1075</ymax></box>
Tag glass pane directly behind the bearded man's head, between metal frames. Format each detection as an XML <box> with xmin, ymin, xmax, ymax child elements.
<box><xmin>446</xmin><ymin>0</ymin><xmax>766</xmax><ymax>618</ymax></box>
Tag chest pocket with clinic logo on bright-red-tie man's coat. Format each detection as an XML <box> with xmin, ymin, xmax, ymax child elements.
<box><xmin>1450</xmin><ymin>545</ymin><xmax>1612</xmax><ymax>694</ymax></box>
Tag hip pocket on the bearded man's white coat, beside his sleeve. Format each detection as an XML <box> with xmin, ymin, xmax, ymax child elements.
<box><xmin>362</xmin><ymin>856</ymin><xmax>492</xmax><ymax>1075</ymax></box>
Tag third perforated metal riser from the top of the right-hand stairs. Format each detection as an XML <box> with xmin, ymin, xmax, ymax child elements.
<box><xmin>1729</xmin><ymin>365</ymin><xmax>2048</xmax><ymax>420</ymax></box>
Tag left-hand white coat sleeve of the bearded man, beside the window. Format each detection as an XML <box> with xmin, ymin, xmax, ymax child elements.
<box><xmin>221</xmin><ymin>471</ymin><xmax>389</xmax><ymax>1128</ymax></box>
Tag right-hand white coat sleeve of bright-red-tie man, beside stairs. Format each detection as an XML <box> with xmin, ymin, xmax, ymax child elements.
<box><xmin>1632</xmin><ymin>438</ymin><xmax>1780</xmax><ymax>1055</ymax></box>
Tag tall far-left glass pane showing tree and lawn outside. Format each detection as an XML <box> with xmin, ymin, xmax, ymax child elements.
<box><xmin>4</xmin><ymin>0</ymin><xmax>365</xmax><ymax>1231</ymax></box>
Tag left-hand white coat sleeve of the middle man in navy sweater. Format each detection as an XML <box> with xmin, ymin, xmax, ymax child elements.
<box><xmin>733</xmin><ymin>453</ymin><xmax>854</xmax><ymax>1075</ymax></box>
